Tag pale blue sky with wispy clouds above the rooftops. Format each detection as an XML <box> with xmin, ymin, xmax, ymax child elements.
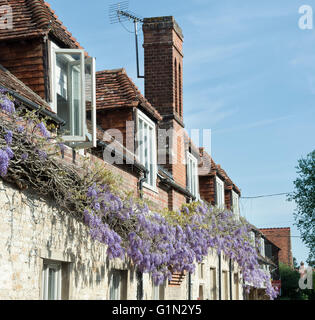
<box><xmin>48</xmin><ymin>0</ymin><xmax>315</xmax><ymax>261</ymax></box>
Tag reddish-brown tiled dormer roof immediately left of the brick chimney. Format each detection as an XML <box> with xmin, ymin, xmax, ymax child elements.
<box><xmin>96</xmin><ymin>68</ymin><xmax>162</xmax><ymax>121</ymax></box>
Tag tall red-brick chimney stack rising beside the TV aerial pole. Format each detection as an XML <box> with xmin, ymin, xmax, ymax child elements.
<box><xmin>143</xmin><ymin>16</ymin><xmax>184</xmax><ymax>126</ymax></box>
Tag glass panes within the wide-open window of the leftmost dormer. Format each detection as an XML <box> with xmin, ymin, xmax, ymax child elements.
<box><xmin>56</xmin><ymin>53</ymin><xmax>83</xmax><ymax>136</ymax></box>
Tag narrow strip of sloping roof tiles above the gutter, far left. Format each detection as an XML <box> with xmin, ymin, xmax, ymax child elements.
<box><xmin>0</xmin><ymin>65</ymin><xmax>51</xmax><ymax>111</ymax></box>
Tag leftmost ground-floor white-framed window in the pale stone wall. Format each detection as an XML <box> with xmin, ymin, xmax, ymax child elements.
<box><xmin>42</xmin><ymin>261</ymin><xmax>62</xmax><ymax>300</ymax></box>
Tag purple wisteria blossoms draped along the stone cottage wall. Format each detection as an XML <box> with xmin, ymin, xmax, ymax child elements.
<box><xmin>0</xmin><ymin>90</ymin><xmax>277</xmax><ymax>299</ymax></box>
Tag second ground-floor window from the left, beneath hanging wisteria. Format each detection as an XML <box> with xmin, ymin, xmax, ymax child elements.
<box><xmin>109</xmin><ymin>270</ymin><xmax>128</xmax><ymax>300</ymax></box>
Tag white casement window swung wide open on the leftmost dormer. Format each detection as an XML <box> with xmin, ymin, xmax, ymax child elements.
<box><xmin>52</xmin><ymin>45</ymin><xmax>96</xmax><ymax>148</ymax></box>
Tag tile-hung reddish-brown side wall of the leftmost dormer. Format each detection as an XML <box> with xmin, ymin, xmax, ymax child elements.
<box><xmin>0</xmin><ymin>39</ymin><xmax>45</xmax><ymax>99</ymax></box>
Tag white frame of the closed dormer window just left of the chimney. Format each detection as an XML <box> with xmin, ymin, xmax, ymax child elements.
<box><xmin>137</xmin><ymin>110</ymin><xmax>157</xmax><ymax>192</ymax></box>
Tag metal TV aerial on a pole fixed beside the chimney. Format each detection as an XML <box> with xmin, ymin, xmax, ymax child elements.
<box><xmin>109</xmin><ymin>1</ymin><xmax>144</xmax><ymax>79</ymax></box>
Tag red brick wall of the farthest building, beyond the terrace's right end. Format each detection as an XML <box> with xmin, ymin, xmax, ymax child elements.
<box><xmin>260</xmin><ymin>228</ymin><xmax>293</xmax><ymax>267</ymax></box>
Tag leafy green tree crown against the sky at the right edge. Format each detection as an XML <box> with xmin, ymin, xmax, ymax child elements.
<box><xmin>289</xmin><ymin>150</ymin><xmax>315</xmax><ymax>267</ymax></box>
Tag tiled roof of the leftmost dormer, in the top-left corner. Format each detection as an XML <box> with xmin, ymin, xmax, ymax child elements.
<box><xmin>0</xmin><ymin>0</ymin><xmax>82</xmax><ymax>49</ymax></box>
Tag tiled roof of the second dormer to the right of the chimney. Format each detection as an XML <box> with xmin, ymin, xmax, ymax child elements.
<box><xmin>198</xmin><ymin>148</ymin><xmax>241</xmax><ymax>194</ymax></box>
